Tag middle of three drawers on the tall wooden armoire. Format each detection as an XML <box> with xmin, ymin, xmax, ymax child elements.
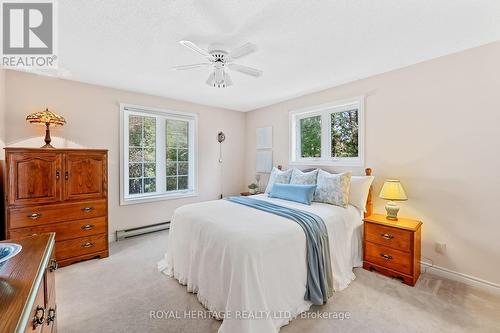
<box><xmin>8</xmin><ymin>216</ymin><xmax>107</xmax><ymax>241</ymax></box>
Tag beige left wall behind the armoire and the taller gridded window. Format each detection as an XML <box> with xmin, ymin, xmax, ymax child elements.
<box><xmin>2</xmin><ymin>71</ymin><xmax>245</xmax><ymax>239</ymax></box>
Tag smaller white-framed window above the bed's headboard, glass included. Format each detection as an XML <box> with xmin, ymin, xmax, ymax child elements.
<box><xmin>290</xmin><ymin>97</ymin><xmax>364</xmax><ymax>166</ymax></box>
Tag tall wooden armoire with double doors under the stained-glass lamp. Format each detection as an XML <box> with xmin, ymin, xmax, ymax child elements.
<box><xmin>5</xmin><ymin>148</ymin><xmax>108</xmax><ymax>266</ymax></box>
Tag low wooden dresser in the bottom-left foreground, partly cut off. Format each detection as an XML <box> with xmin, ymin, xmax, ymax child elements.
<box><xmin>0</xmin><ymin>233</ymin><xmax>57</xmax><ymax>333</ymax></box>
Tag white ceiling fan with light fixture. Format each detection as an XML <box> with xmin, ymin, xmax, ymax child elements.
<box><xmin>172</xmin><ymin>40</ymin><xmax>262</xmax><ymax>88</ymax></box>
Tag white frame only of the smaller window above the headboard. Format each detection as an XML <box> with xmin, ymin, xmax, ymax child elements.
<box><xmin>289</xmin><ymin>96</ymin><xmax>365</xmax><ymax>167</ymax></box>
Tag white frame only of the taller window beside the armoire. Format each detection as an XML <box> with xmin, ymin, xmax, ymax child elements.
<box><xmin>120</xmin><ymin>103</ymin><xmax>198</xmax><ymax>205</ymax></box>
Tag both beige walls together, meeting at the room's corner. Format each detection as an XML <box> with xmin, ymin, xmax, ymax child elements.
<box><xmin>0</xmin><ymin>43</ymin><xmax>500</xmax><ymax>284</ymax></box>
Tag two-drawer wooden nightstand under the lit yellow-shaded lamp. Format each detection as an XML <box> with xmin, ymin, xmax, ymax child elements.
<box><xmin>363</xmin><ymin>214</ymin><xmax>422</xmax><ymax>286</ymax></box>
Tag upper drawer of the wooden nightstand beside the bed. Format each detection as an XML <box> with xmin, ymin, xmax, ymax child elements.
<box><xmin>365</xmin><ymin>222</ymin><xmax>413</xmax><ymax>252</ymax></box>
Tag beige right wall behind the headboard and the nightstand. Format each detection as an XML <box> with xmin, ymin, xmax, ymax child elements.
<box><xmin>245</xmin><ymin>42</ymin><xmax>500</xmax><ymax>284</ymax></box>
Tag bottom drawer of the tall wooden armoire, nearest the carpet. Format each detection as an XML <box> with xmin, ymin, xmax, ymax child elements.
<box><xmin>56</xmin><ymin>234</ymin><xmax>108</xmax><ymax>261</ymax></box>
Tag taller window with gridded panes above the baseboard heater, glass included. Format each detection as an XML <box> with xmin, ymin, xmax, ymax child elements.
<box><xmin>120</xmin><ymin>104</ymin><xmax>197</xmax><ymax>204</ymax></box>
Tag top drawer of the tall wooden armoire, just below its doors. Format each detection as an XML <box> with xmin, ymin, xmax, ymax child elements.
<box><xmin>7</xmin><ymin>200</ymin><xmax>107</xmax><ymax>229</ymax></box>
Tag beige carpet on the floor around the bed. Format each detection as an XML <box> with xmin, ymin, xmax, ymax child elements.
<box><xmin>56</xmin><ymin>232</ymin><xmax>500</xmax><ymax>333</ymax></box>
